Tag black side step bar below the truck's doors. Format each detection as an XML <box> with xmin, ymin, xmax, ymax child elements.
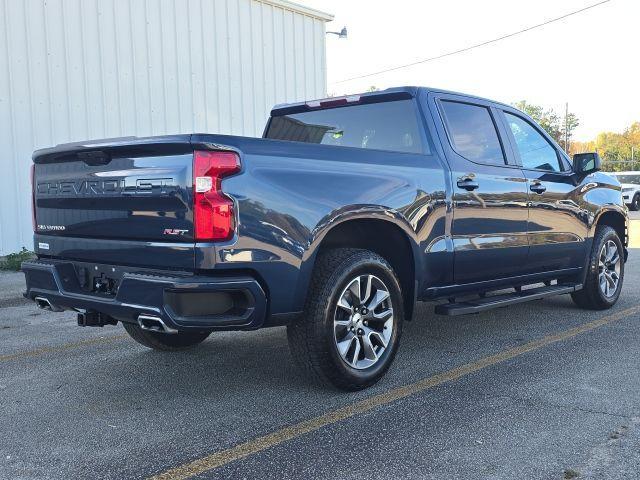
<box><xmin>435</xmin><ymin>283</ymin><xmax>582</xmax><ymax>316</ymax></box>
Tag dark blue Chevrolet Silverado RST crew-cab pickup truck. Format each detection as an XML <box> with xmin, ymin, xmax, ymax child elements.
<box><xmin>22</xmin><ymin>87</ymin><xmax>628</xmax><ymax>390</ymax></box>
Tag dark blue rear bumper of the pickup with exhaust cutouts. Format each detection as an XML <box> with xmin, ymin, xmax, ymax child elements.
<box><xmin>22</xmin><ymin>260</ymin><xmax>267</xmax><ymax>330</ymax></box>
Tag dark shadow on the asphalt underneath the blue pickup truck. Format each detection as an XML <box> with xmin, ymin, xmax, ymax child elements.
<box><xmin>69</xmin><ymin>284</ymin><xmax>627</xmax><ymax>408</ymax></box>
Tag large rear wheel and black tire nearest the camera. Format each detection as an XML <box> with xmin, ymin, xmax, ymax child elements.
<box><xmin>287</xmin><ymin>248</ymin><xmax>404</xmax><ymax>391</ymax></box>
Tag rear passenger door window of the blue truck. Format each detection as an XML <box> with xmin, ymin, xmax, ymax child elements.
<box><xmin>442</xmin><ymin>101</ymin><xmax>505</xmax><ymax>165</ymax></box>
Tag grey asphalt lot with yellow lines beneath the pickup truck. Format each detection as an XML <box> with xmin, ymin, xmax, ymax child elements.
<box><xmin>0</xmin><ymin>249</ymin><xmax>640</xmax><ymax>480</ymax></box>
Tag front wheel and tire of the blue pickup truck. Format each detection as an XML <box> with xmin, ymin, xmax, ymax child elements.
<box><xmin>571</xmin><ymin>226</ymin><xmax>624</xmax><ymax>310</ymax></box>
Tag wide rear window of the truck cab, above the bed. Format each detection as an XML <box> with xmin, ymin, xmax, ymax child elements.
<box><xmin>265</xmin><ymin>100</ymin><xmax>429</xmax><ymax>153</ymax></box>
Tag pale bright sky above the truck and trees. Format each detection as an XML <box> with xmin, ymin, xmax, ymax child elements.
<box><xmin>298</xmin><ymin>0</ymin><xmax>640</xmax><ymax>141</ymax></box>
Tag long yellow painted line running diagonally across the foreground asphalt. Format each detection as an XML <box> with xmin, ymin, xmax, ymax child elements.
<box><xmin>151</xmin><ymin>306</ymin><xmax>640</xmax><ymax>480</ymax></box>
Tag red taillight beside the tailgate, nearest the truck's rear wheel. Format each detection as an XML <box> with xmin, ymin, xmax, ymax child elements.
<box><xmin>193</xmin><ymin>151</ymin><xmax>240</xmax><ymax>241</ymax></box>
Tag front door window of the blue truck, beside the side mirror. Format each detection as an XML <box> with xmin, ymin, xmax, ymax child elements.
<box><xmin>504</xmin><ymin>112</ymin><xmax>562</xmax><ymax>172</ymax></box>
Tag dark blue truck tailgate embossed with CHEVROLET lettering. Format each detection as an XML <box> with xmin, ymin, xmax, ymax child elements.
<box><xmin>33</xmin><ymin>135</ymin><xmax>194</xmax><ymax>268</ymax></box>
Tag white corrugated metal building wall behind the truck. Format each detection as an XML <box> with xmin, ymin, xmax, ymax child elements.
<box><xmin>0</xmin><ymin>0</ymin><xmax>329</xmax><ymax>255</ymax></box>
